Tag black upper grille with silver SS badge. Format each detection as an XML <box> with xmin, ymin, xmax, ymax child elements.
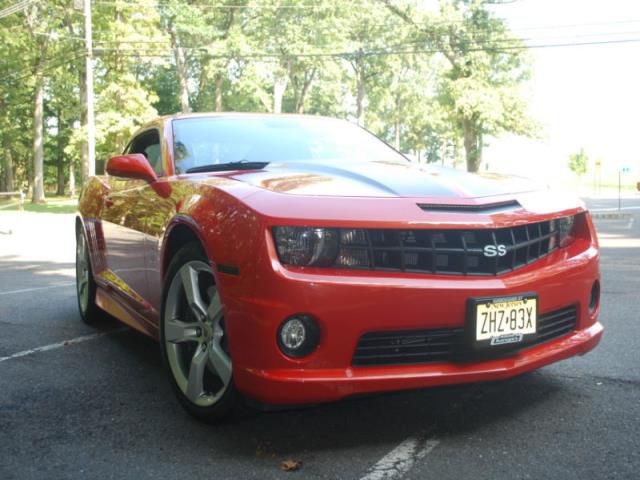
<box><xmin>340</xmin><ymin>220</ymin><xmax>559</xmax><ymax>275</ymax></box>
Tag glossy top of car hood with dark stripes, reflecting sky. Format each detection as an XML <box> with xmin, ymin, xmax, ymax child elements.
<box><xmin>228</xmin><ymin>162</ymin><xmax>544</xmax><ymax>198</ymax></box>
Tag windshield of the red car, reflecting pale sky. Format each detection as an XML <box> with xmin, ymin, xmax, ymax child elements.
<box><xmin>173</xmin><ymin>116</ymin><xmax>407</xmax><ymax>174</ymax></box>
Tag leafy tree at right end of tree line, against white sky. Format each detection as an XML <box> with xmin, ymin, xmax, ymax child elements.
<box><xmin>384</xmin><ymin>0</ymin><xmax>538</xmax><ymax>172</ymax></box>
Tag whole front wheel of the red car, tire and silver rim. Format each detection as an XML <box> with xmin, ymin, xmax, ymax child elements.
<box><xmin>160</xmin><ymin>243</ymin><xmax>238</xmax><ymax>422</ymax></box>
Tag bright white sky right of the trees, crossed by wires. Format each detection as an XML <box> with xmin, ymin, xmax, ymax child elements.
<box><xmin>485</xmin><ymin>0</ymin><xmax>640</xmax><ymax>183</ymax></box>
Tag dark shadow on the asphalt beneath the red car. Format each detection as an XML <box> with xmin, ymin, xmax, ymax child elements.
<box><xmin>101</xmin><ymin>331</ymin><xmax>564</xmax><ymax>461</ymax></box>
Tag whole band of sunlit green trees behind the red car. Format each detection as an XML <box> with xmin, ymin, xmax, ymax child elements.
<box><xmin>0</xmin><ymin>0</ymin><xmax>536</xmax><ymax>200</ymax></box>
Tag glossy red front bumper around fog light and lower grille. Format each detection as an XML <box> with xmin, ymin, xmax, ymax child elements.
<box><xmin>221</xmin><ymin>226</ymin><xmax>603</xmax><ymax>404</ymax></box>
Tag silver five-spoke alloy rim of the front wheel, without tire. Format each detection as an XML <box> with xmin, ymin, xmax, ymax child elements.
<box><xmin>163</xmin><ymin>260</ymin><xmax>232</xmax><ymax>407</ymax></box>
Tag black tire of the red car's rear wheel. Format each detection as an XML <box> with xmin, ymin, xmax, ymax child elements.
<box><xmin>76</xmin><ymin>227</ymin><xmax>104</xmax><ymax>325</ymax></box>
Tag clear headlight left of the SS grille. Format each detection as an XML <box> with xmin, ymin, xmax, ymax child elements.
<box><xmin>273</xmin><ymin>227</ymin><xmax>338</xmax><ymax>267</ymax></box>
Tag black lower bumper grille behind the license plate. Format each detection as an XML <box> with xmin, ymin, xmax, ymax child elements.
<box><xmin>352</xmin><ymin>305</ymin><xmax>577</xmax><ymax>367</ymax></box>
